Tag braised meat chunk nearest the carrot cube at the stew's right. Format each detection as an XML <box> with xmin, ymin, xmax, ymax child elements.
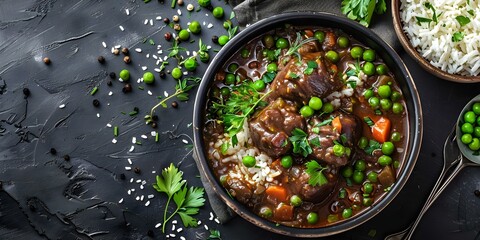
<box><xmin>308</xmin><ymin>113</ymin><xmax>362</xmax><ymax>167</ymax></box>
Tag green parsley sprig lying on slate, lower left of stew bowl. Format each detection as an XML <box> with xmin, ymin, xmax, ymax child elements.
<box><xmin>153</xmin><ymin>163</ymin><xmax>205</xmax><ymax>233</ymax></box>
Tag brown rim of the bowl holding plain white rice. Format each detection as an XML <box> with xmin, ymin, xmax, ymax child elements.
<box><xmin>391</xmin><ymin>0</ymin><xmax>480</xmax><ymax>83</ymax></box>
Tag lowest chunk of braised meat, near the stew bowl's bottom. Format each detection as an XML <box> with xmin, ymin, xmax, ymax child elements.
<box><xmin>288</xmin><ymin>165</ymin><xmax>338</xmax><ymax>204</ymax></box>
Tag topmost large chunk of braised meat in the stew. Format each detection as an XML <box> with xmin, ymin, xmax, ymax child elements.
<box><xmin>268</xmin><ymin>52</ymin><xmax>343</xmax><ymax>104</ymax></box>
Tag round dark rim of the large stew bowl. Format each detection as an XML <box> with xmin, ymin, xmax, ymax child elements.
<box><xmin>193</xmin><ymin>11</ymin><xmax>423</xmax><ymax>237</ymax></box>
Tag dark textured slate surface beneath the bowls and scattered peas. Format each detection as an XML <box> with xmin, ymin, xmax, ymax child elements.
<box><xmin>0</xmin><ymin>0</ymin><xmax>480</xmax><ymax>239</ymax></box>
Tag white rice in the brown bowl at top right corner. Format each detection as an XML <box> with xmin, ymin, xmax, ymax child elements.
<box><xmin>400</xmin><ymin>0</ymin><xmax>480</xmax><ymax>76</ymax></box>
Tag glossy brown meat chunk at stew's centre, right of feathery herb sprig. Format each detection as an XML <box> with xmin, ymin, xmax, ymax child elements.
<box><xmin>249</xmin><ymin>98</ymin><xmax>305</xmax><ymax>158</ymax></box>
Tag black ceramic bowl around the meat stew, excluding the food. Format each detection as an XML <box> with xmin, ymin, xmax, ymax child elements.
<box><xmin>193</xmin><ymin>12</ymin><xmax>423</xmax><ymax>237</ymax></box>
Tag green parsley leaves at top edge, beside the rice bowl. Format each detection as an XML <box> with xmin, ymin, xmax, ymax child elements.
<box><xmin>341</xmin><ymin>0</ymin><xmax>387</xmax><ymax>27</ymax></box>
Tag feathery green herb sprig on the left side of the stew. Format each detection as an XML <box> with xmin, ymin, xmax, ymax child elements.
<box><xmin>212</xmin><ymin>83</ymin><xmax>271</xmax><ymax>146</ymax></box>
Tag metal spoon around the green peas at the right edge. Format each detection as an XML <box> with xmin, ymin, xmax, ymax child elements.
<box><xmin>385</xmin><ymin>95</ymin><xmax>480</xmax><ymax>240</ymax></box>
